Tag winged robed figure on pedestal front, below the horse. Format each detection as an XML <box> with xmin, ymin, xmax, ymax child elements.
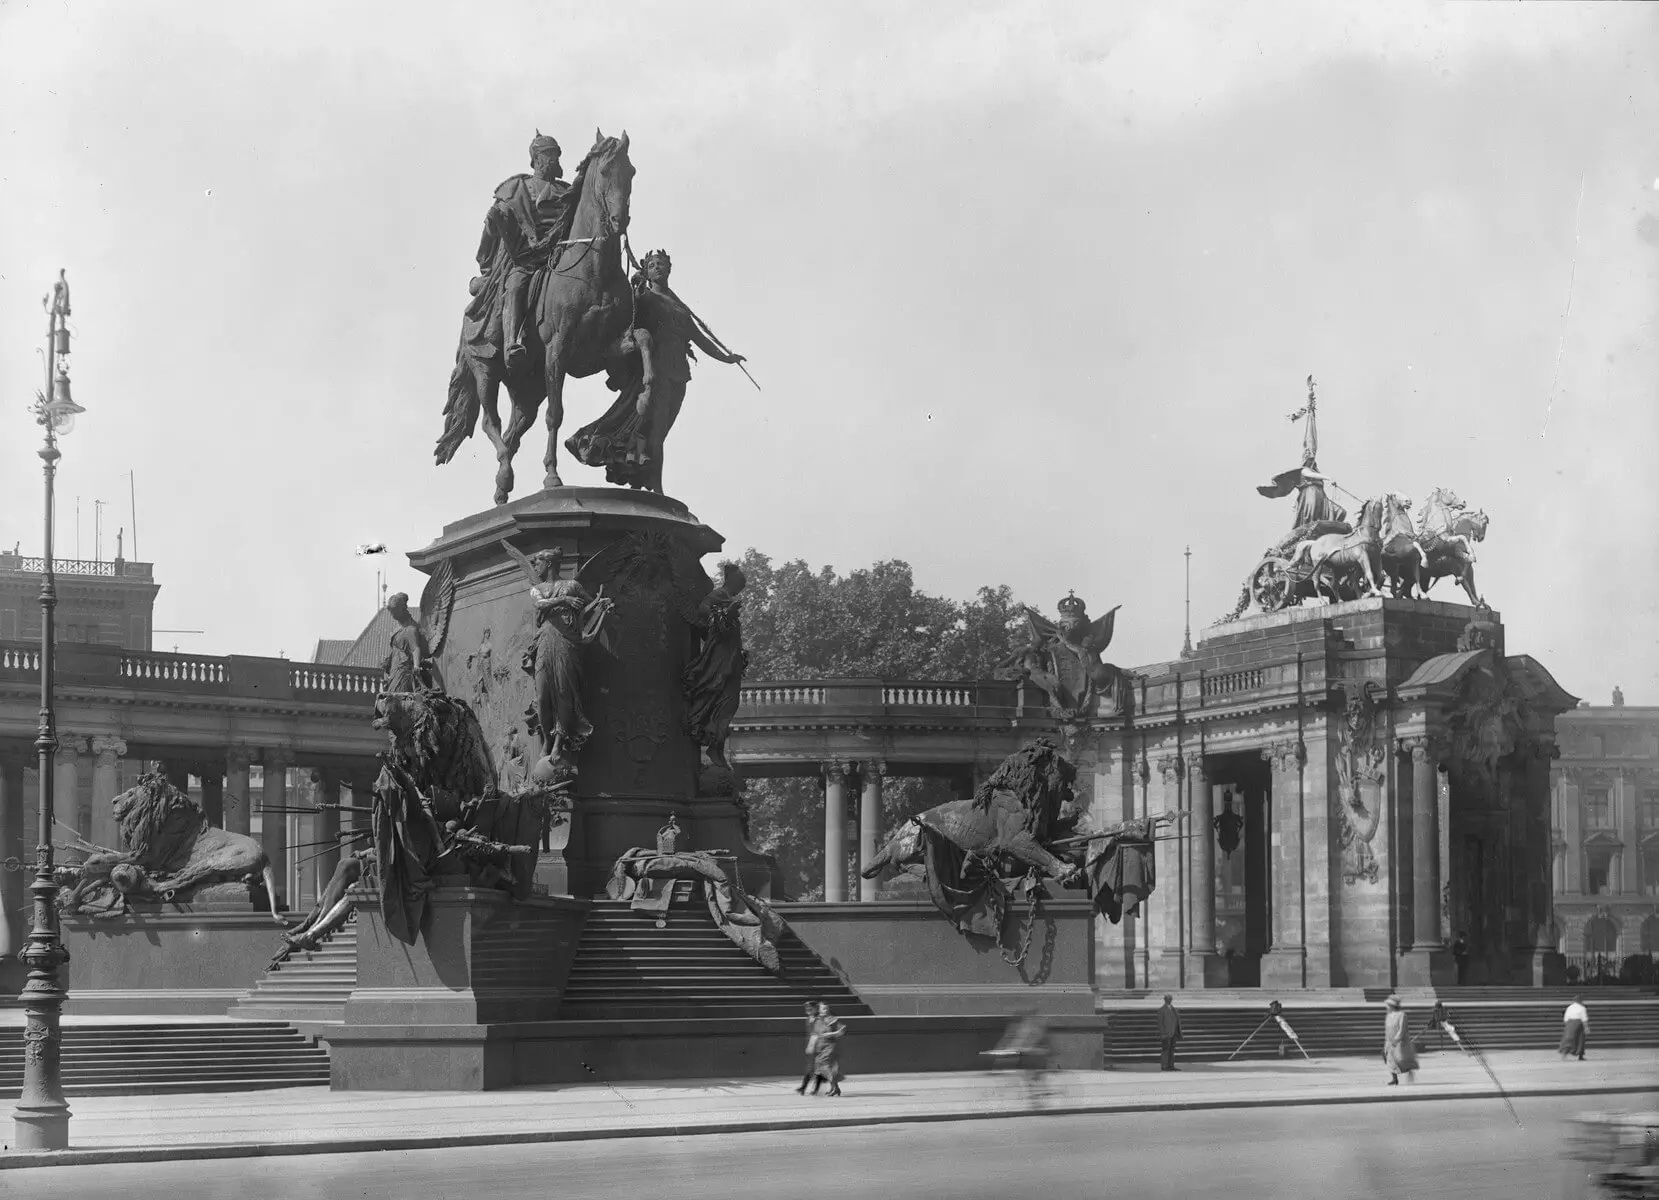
<box><xmin>501</xmin><ymin>541</ymin><xmax>614</xmax><ymax>782</ymax></box>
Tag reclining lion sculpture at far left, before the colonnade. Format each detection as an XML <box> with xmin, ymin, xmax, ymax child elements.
<box><xmin>56</xmin><ymin>773</ymin><xmax>287</xmax><ymax>924</ymax></box>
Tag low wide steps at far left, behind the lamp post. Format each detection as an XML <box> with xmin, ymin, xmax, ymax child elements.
<box><xmin>0</xmin><ymin>1021</ymin><xmax>328</xmax><ymax>1099</ymax></box>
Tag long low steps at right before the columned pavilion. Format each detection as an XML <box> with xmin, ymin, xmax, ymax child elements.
<box><xmin>1107</xmin><ymin>989</ymin><xmax>1659</xmax><ymax>1066</ymax></box>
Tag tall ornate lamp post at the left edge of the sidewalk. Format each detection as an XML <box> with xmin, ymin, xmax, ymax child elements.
<box><xmin>12</xmin><ymin>271</ymin><xmax>85</xmax><ymax>1150</ymax></box>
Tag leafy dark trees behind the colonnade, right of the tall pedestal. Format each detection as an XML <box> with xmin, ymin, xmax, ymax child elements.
<box><xmin>742</xmin><ymin>549</ymin><xmax>1025</xmax><ymax>900</ymax></box>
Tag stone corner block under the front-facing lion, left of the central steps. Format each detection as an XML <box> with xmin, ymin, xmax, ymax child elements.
<box><xmin>345</xmin><ymin>888</ymin><xmax>587</xmax><ymax>1029</ymax></box>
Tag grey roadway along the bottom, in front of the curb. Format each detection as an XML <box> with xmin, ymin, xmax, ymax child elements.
<box><xmin>0</xmin><ymin>1089</ymin><xmax>1659</xmax><ymax>1200</ymax></box>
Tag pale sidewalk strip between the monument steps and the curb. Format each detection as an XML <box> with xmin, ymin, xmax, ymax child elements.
<box><xmin>0</xmin><ymin>1049</ymin><xmax>1659</xmax><ymax>1183</ymax></box>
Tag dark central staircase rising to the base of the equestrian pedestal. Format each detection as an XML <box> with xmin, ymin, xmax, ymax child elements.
<box><xmin>559</xmin><ymin>883</ymin><xmax>869</xmax><ymax>1021</ymax></box>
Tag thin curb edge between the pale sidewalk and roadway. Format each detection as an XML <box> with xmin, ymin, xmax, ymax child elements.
<box><xmin>0</xmin><ymin>1084</ymin><xmax>1659</xmax><ymax>1170</ymax></box>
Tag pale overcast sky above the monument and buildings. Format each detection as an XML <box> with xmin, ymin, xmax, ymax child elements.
<box><xmin>0</xmin><ymin>0</ymin><xmax>1659</xmax><ymax>704</ymax></box>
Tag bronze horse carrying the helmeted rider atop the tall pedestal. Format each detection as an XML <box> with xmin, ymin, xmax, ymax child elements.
<box><xmin>435</xmin><ymin>131</ymin><xmax>634</xmax><ymax>505</ymax></box>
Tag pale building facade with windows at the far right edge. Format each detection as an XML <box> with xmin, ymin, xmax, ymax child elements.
<box><xmin>1551</xmin><ymin>695</ymin><xmax>1659</xmax><ymax>971</ymax></box>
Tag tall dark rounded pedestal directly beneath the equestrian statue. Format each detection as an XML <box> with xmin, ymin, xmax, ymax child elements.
<box><xmin>410</xmin><ymin>488</ymin><xmax>770</xmax><ymax>896</ymax></box>
